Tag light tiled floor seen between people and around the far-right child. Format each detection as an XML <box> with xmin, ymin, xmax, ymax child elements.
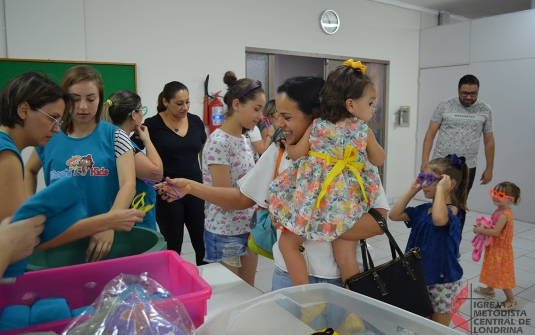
<box><xmin>182</xmin><ymin>201</ymin><xmax>535</xmax><ymax>334</ymax></box>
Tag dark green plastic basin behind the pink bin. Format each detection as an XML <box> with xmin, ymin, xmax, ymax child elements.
<box><xmin>26</xmin><ymin>227</ymin><xmax>167</xmax><ymax>271</ymax></box>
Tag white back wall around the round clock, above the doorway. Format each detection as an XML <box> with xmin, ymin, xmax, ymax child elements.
<box><xmin>0</xmin><ymin>0</ymin><xmax>421</xmax><ymax>200</ymax></box>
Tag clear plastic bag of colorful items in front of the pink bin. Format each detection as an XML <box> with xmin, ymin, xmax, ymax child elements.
<box><xmin>62</xmin><ymin>273</ymin><xmax>195</xmax><ymax>335</ymax></box>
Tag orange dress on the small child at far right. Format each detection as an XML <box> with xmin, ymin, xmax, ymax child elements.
<box><xmin>479</xmin><ymin>208</ymin><xmax>516</xmax><ymax>289</ymax></box>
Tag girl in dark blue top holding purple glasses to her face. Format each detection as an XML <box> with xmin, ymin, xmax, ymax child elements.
<box><xmin>388</xmin><ymin>154</ymin><xmax>468</xmax><ymax>326</ymax></box>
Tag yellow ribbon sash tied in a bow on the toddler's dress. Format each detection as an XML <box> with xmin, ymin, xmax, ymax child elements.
<box><xmin>308</xmin><ymin>145</ymin><xmax>368</xmax><ymax>208</ymax></box>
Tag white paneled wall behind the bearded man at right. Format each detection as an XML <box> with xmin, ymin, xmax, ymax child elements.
<box><xmin>415</xmin><ymin>10</ymin><xmax>535</xmax><ymax>223</ymax></box>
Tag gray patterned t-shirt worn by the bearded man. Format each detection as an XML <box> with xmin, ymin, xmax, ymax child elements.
<box><xmin>431</xmin><ymin>97</ymin><xmax>494</xmax><ymax>168</ymax></box>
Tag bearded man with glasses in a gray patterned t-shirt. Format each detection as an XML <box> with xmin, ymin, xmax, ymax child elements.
<box><xmin>420</xmin><ymin>74</ymin><xmax>494</xmax><ymax>235</ymax></box>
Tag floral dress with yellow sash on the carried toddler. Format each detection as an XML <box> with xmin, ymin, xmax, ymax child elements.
<box><xmin>269</xmin><ymin>118</ymin><xmax>380</xmax><ymax>241</ymax></box>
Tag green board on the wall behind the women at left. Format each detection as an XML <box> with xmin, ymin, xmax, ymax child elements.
<box><xmin>0</xmin><ymin>58</ymin><xmax>137</xmax><ymax>99</ymax></box>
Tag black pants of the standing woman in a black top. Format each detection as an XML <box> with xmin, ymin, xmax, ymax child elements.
<box><xmin>156</xmin><ymin>195</ymin><xmax>207</xmax><ymax>265</ymax></box>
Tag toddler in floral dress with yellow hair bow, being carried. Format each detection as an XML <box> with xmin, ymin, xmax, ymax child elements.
<box><xmin>269</xmin><ymin>59</ymin><xmax>385</xmax><ymax>285</ymax></box>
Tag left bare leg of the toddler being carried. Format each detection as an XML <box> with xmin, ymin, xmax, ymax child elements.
<box><xmin>279</xmin><ymin>229</ymin><xmax>310</xmax><ymax>285</ymax></box>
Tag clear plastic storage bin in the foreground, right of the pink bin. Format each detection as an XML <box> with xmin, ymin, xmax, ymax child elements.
<box><xmin>197</xmin><ymin>284</ymin><xmax>460</xmax><ymax>335</ymax></box>
